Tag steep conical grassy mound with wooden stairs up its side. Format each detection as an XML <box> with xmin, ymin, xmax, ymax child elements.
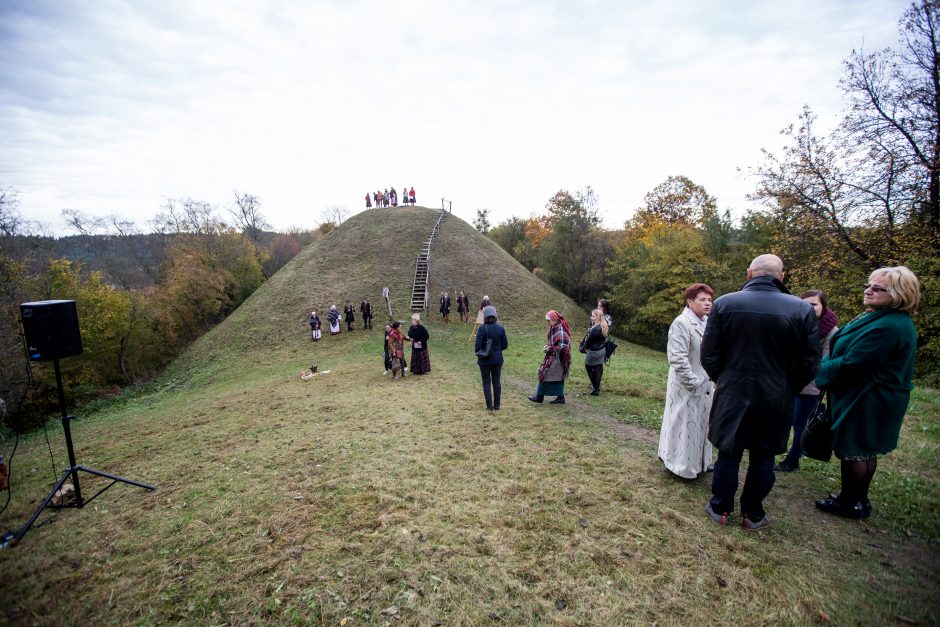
<box><xmin>171</xmin><ymin>207</ymin><xmax>587</xmax><ymax>371</ymax></box>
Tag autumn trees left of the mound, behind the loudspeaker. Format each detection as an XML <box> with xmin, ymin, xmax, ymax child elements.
<box><xmin>0</xmin><ymin>194</ymin><xmax>335</xmax><ymax>430</ymax></box>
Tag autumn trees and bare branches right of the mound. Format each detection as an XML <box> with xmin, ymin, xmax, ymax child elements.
<box><xmin>482</xmin><ymin>0</ymin><xmax>940</xmax><ymax>383</ymax></box>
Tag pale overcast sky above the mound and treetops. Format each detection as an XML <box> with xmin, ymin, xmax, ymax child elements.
<box><xmin>0</xmin><ymin>0</ymin><xmax>909</xmax><ymax>233</ymax></box>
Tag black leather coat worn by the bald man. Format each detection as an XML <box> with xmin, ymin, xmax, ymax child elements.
<box><xmin>702</xmin><ymin>276</ymin><xmax>820</xmax><ymax>454</ymax></box>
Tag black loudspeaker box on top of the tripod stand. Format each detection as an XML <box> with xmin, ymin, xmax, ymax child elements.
<box><xmin>20</xmin><ymin>300</ymin><xmax>82</xmax><ymax>361</ymax></box>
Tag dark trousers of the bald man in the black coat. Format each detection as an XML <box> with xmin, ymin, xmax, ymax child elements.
<box><xmin>711</xmin><ymin>448</ymin><xmax>775</xmax><ymax>522</ymax></box>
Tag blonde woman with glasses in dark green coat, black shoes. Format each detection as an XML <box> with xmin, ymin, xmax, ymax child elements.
<box><xmin>816</xmin><ymin>266</ymin><xmax>920</xmax><ymax>518</ymax></box>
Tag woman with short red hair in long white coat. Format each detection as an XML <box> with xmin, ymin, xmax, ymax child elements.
<box><xmin>659</xmin><ymin>283</ymin><xmax>715</xmax><ymax>479</ymax></box>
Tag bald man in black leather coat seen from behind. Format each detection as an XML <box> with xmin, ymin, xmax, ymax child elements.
<box><xmin>702</xmin><ymin>254</ymin><xmax>820</xmax><ymax>531</ymax></box>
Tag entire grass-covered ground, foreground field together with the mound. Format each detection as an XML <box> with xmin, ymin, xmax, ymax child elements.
<box><xmin>0</xmin><ymin>208</ymin><xmax>940</xmax><ymax>625</ymax></box>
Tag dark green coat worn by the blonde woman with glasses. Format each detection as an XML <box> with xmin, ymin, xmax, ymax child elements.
<box><xmin>816</xmin><ymin>309</ymin><xmax>917</xmax><ymax>457</ymax></box>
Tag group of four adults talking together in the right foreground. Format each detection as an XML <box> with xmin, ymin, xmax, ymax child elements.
<box><xmin>659</xmin><ymin>254</ymin><xmax>920</xmax><ymax>531</ymax></box>
